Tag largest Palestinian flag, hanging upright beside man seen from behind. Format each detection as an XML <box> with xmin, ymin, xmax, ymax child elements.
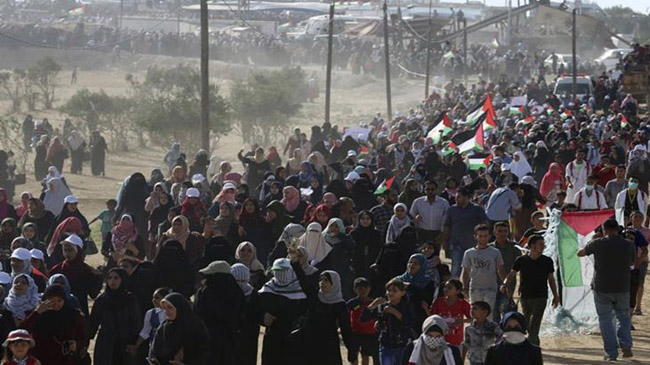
<box><xmin>544</xmin><ymin>209</ymin><xmax>614</xmax><ymax>317</ymax></box>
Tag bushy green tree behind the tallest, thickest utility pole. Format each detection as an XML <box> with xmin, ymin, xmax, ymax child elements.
<box><xmin>127</xmin><ymin>66</ymin><xmax>230</xmax><ymax>150</ymax></box>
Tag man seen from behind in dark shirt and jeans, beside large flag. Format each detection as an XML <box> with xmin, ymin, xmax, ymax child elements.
<box><xmin>578</xmin><ymin>218</ymin><xmax>634</xmax><ymax>361</ymax></box>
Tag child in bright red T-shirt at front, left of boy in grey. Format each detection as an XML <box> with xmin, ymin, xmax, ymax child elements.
<box><xmin>430</xmin><ymin>279</ymin><xmax>472</xmax><ymax>346</ymax></box>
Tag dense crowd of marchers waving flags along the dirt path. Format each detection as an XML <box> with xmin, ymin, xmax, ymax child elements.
<box><xmin>0</xmin><ymin>40</ymin><xmax>650</xmax><ymax>365</ymax></box>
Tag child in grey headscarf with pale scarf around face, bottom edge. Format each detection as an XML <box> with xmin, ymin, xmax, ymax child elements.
<box><xmin>408</xmin><ymin>315</ymin><xmax>463</xmax><ymax>365</ymax></box>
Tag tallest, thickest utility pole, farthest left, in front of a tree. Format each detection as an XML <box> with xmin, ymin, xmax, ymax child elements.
<box><xmin>201</xmin><ymin>0</ymin><xmax>210</xmax><ymax>151</ymax></box>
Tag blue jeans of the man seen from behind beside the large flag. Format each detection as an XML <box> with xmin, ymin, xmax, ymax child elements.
<box><xmin>593</xmin><ymin>291</ymin><xmax>632</xmax><ymax>358</ymax></box>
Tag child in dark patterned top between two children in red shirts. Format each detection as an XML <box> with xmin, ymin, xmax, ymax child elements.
<box><xmin>361</xmin><ymin>279</ymin><xmax>414</xmax><ymax>365</ymax></box>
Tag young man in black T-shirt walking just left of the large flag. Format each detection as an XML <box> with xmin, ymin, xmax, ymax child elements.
<box><xmin>504</xmin><ymin>234</ymin><xmax>559</xmax><ymax>346</ymax></box>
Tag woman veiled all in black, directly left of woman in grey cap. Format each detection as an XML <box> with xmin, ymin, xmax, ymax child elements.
<box><xmin>153</xmin><ymin>240</ymin><xmax>196</xmax><ymax>297</ymax></box>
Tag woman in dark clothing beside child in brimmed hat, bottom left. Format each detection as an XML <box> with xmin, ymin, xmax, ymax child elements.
<box><xmin>22</xmin><ymin>285</ymin><xmax>89</xmax><ymax>365</ymax></box>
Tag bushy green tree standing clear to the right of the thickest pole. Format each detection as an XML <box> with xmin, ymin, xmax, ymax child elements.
<box><xmin>230</xmin><ymin>67</ymin><xmax>307</xmax><ymax>145</ymax></box>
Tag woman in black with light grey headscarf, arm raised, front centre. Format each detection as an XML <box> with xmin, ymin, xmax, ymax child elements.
<box><xmin>291</xmin><ymin>260</ymin><xmax>352</xmax><ymax>365</ymax></box>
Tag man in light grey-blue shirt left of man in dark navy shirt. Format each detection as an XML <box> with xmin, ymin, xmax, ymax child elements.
<box><xmin>411</xmin><ymin>181</ymin><xmax>449</xmax><ymax>244</ymax></box>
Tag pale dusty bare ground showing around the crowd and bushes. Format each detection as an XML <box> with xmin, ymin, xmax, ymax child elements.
<box><xmin>0</xmin><ymin>49</ymin><xmax>650</xmax><ymax>364</ymax></box>
